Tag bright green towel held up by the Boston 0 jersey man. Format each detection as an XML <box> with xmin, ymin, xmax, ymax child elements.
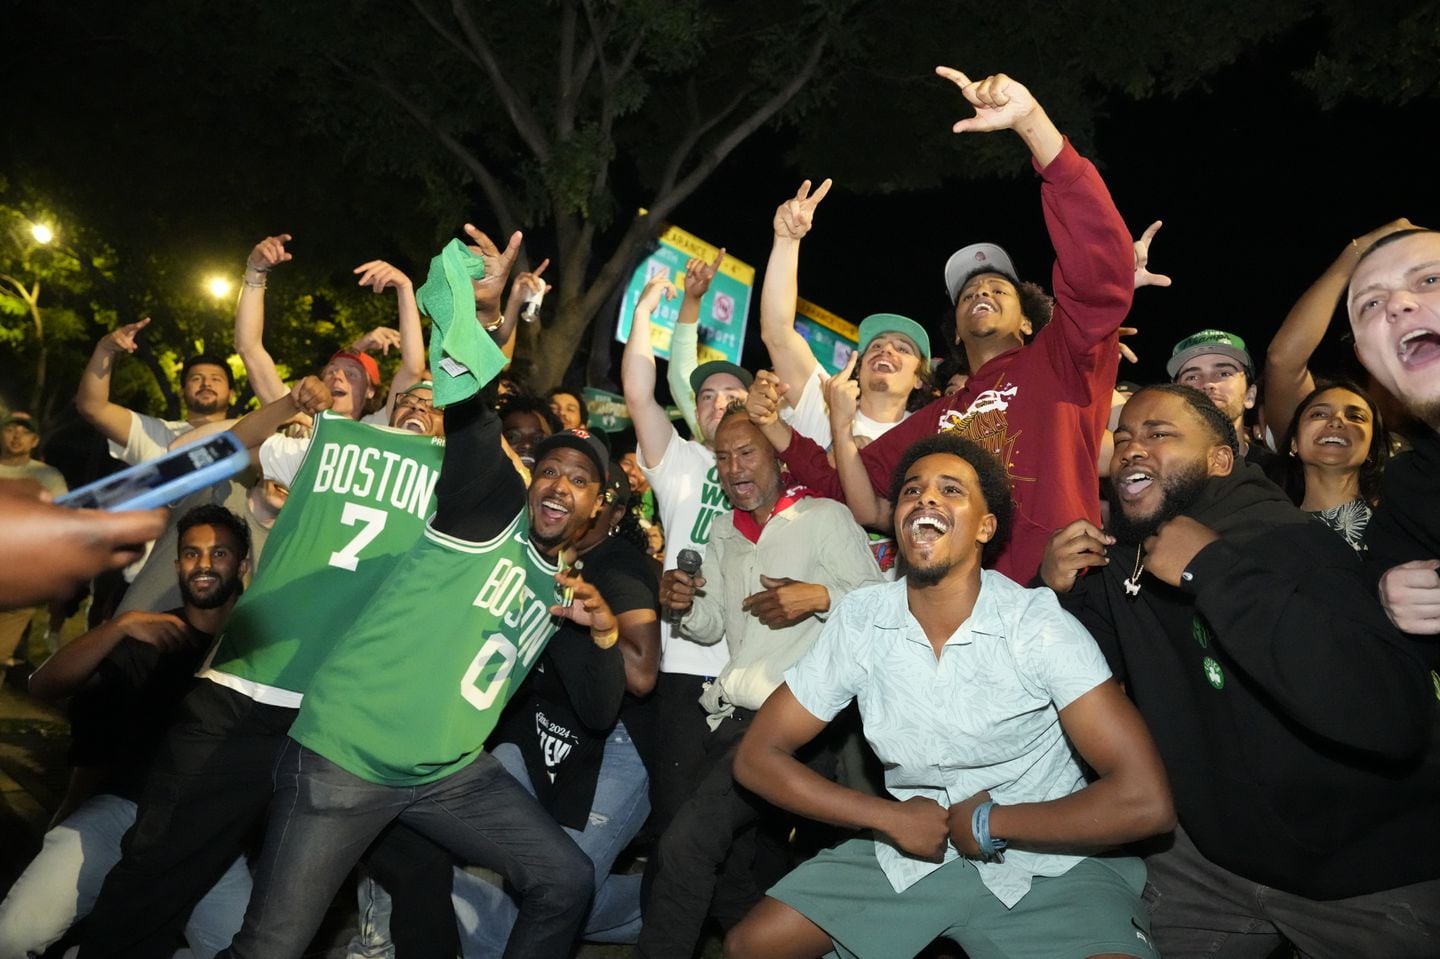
<box><xmin>415</xmin><ymin>239</ymin><xmax>505</xmax><ymax>409</ymax></box>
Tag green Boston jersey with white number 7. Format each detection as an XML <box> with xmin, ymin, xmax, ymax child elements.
<box><xmin>203</xmin><ymin>413</ymin><xmax>445</xmax><ymax>707</ymax></box>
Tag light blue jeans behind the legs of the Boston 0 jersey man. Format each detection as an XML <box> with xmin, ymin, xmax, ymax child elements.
<box><xmin>454</xmin><ymin>723</ymin><xmax>649</xmax><ymax>959</ymax></box>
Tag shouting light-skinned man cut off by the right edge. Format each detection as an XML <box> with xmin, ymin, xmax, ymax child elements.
<box><xmin>1346</xmin><ymin>229</ymin><xmax>1440</xmax><ymax>642</ymax></box>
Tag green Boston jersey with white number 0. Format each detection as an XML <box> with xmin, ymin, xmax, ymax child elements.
<box><xmin>289</xmin><ymin>505</ymin><xmax>559</xmax><ymax>786</ymax></box>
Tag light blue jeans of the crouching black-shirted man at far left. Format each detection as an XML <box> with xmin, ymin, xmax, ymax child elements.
<box><xmin>0</xmin><ymin>793</ymin><xmax>251</xmax><ymax>959</ymax></box>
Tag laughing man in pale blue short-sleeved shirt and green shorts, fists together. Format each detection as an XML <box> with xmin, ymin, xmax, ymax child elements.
<box><xmin>726</xmin><ymin>435</ymin><xmax>1174</xmax><ymax>959</ymax></box>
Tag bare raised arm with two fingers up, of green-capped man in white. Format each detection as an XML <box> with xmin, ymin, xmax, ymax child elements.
<box><xmin>760</xmin><ymin>180</ymin><xmax>831</xmax><ymax>389</ymax></box>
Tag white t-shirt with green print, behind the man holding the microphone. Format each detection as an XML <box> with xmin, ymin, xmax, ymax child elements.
<box><xmin>635</xmin><ymin>429</ymin><xmax>730</xmax><ymax>677</ymax></box>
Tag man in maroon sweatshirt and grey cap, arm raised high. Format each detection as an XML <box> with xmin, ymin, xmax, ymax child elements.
<box><xmin>772</xmin><ymin>66</ymin><xmax>1135</xmax><ymax>582</ymax></box>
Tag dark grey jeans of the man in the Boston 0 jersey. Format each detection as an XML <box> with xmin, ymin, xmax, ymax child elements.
<box><xmin>226</xmin><ymin>740</ymin><xmax>595</xmax><ymax>959</ymax></box>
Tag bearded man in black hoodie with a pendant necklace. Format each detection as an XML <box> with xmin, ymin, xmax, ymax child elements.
<box><xmin>1041</xmin><ymin>384</ymin><xmax>1440</xmax><ymax>958</ymax></box>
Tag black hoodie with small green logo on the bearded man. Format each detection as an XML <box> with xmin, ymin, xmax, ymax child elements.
<box><xmin>1061</xmin><ymin>465</ymin><xmax>1440</xmax><ymax>900</ymax></box>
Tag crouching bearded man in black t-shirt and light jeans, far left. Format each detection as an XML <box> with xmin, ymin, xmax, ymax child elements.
<box><xmin>0</xmin><ymin>505</ymin><xmax>251</xmax><ymax>959</ymax></box>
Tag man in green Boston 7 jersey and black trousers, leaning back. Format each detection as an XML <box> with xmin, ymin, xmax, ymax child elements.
<box><xmin>81</xmin><ymin>377</ymin><xmax>444</xmax><ymax>958</ymax></box>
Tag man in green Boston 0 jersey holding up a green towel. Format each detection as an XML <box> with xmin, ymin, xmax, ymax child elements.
<box><xmin>225</xmin><ymin>228</ymin><xmax>624</xmax><ymax>959</ymax></box>
